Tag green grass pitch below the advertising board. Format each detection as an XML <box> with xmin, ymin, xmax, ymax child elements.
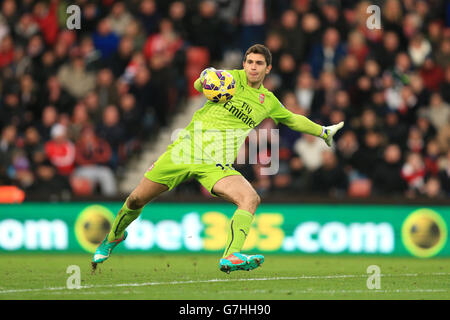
<box><xmin>0</xmin><ymin>254</ymin><xmax>450</xmax><ymax>300</ymax></box>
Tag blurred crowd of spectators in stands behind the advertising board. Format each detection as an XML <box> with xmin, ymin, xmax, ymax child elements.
<box><xmin>0</xmin><ymin>0</ymin><xmax>450</xmax><ymax>199</ymax></box>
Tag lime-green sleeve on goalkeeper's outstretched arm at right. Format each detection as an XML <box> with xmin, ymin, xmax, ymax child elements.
<box><xmin>269</xmin><ymin>96</ymin><xmax>322</xmax><ymax>137</ymax></box>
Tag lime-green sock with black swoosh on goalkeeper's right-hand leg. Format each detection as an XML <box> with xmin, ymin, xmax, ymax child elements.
<box><xmin>223</xmin><ymin>209</ymin><xmax>253</xmax><ymax>258</ymax></box>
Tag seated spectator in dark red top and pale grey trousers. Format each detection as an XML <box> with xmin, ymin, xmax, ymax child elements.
<box><xmin>74</xmin><ymin>126</ymin><xmax>117</xmax><ymax>196</ymax></box>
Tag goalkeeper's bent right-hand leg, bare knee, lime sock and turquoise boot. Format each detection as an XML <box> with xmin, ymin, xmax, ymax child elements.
<box><xmin>212</xmin><ymin>175</ymin><xmax>264</xmax><ymax>273</ymax></box>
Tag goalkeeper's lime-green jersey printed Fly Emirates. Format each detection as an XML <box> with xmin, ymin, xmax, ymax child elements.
<box><xmin>172</xmin><ymin>70</ymin><xmax>322</xmax><ymax>164</ymax></box>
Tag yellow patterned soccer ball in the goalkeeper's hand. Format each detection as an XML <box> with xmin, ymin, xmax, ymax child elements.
<box><xmin>201</xmin><ymin>69</ymin><xmax>236</xmax><ymax>102</ymax></box>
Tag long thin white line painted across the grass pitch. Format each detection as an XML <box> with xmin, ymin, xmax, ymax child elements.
<box><xmin>0</xmin><ymin>272</ymin><xmax>450</xmax><ymax>294</ymax></box>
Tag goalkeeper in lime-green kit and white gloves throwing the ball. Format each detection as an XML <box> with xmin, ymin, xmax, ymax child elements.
<box><xmin>92</xmin><ymin>44</ymin><xmax>344</xmax><ymax>273</ymax></box>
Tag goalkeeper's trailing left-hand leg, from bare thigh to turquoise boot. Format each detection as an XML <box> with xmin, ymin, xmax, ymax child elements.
<box><xmin>92</xmin><ymin>177</ymin><xmax>169</xmax><ymax>264</ymax></box>
